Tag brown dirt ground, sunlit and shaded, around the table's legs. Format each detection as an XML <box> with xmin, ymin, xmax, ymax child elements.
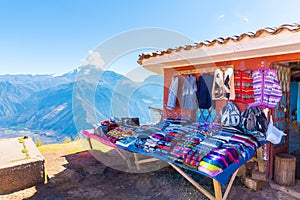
<box><xmin>0</xmin><ymin>143</ymin><xmax>300</xmax><ymax>200</ymax></box>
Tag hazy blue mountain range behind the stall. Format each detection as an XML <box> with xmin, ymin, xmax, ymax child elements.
<box><xmin>0</xmin><ymin>65</ymin><xmax>163</xmax><ymax>143</ymax></box>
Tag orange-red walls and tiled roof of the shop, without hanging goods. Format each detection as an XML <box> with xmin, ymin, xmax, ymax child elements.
<box><xmin>138</xmin><ymin>23</ymin><xmax>300</xmax><ymax>178</ymax></box>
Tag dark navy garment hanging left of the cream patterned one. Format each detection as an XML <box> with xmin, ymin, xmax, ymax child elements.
<box><xmin>197</xmin><ymin>74</ymin><xmax>214</xmax><ymax>109</ymax></box>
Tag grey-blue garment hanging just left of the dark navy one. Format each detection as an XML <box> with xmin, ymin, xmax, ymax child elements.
<box><xmin>181</xmin><ymin>75</ymin><xmax>198</xmax><ymax>110</ymax></box>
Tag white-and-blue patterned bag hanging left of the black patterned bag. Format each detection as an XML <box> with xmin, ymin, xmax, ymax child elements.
<box><xmin>219</xmin><ymin>101</ymin><xmax>241</xmax><ymax>127</ymax></box>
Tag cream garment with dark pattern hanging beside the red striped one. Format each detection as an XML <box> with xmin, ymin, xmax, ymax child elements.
<box><xmin>212</xmin><ymin>68</ymin><xmax>235</xmax><ymax>100</ymax></box>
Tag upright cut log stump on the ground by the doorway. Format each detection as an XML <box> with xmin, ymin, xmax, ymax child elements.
<box><xmin>274</xmin><ymin>153</ymin><xmax>296</xmax><ymax>186</ymax></box>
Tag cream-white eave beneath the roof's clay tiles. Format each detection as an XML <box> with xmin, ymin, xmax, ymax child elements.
<box><xmin>141</xmin><ymin>31</ymin><xmax>300</xmax><ymax>74</ymax></box>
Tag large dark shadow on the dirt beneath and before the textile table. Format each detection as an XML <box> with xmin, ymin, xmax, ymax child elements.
<box><xmin>27</xmin><ymin>151</ymin><xmax>213</xmax><ymax>200</ymax></box>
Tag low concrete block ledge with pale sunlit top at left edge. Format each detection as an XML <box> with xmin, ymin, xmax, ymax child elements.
<box><xmin>0</xmin><ymin>138</ymin><xmax>45</xmax><ymax>195</ymax></box>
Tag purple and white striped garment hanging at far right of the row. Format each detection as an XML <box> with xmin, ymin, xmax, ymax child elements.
<box><xmin>250</xmin><ymin>68</ymin><xmax>282</xmax><ymax>108</ymax></box>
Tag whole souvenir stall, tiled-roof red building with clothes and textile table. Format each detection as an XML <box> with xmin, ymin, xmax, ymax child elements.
<box><xmin>83</xmin><ymin>24</ymin><xmax>300</xmax><ymax>199</ymax></box>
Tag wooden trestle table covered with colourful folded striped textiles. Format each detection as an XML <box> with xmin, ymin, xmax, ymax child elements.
<box><xmin>82</xmin><ymin>115</ymin><xmax>262</xmax><ymax>199</ymax></box>
